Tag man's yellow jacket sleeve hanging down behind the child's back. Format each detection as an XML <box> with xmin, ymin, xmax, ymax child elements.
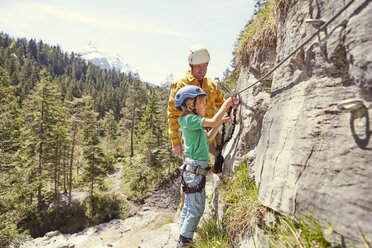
<box><xmin>168</xmin><ymin>82</ymin><xmax>182</xmax><ymax>147</ymax></box>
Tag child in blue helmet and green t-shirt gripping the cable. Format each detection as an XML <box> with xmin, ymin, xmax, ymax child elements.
<box><xmin>175</xmin><ymin>85</ymin><xmax>232</xmax><ymax>247</ymax></box>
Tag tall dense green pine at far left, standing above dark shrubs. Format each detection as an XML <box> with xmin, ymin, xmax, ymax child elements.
<box><xmin>21</xmin><ymin>70</ymin><xmax>62</xmax><ymax>212</ymax></box>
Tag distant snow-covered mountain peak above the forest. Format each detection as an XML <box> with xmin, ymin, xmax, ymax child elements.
<box><xmin>79</xmin><ymin>41</ymin><xmax>135</xmax><ymax>73</ymax></box>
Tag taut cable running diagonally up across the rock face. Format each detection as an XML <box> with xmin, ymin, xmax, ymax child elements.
<box><xmin>233</xmin><ymin>0</ymin><xmax>354</xmax><ymax>96</ymax></box>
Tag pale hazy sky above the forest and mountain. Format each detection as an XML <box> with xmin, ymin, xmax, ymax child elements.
<box><xmin>0</xmin><ymin>0</ymin><xmax>255</xmax><ymax>85</ymax></box>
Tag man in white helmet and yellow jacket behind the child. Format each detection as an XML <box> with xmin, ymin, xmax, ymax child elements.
<box><xmin>168</xmin><ymin>45</ymin><xmax>224</xmax><ymax>157</ymax></box>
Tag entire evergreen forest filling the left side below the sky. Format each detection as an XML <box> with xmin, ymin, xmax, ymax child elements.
<box><xmin>0</xmin><ymin>33</ymin><xmax>178</xmax><ymax>247</ymax></box>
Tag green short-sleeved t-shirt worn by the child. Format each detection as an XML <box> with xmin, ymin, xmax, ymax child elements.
<box><xmin>178</xmin><ymin>114</ymin><xmax>209</xmax><ymax>161</ymax></box>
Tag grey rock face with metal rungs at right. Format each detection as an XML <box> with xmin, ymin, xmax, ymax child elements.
<box><xmin>224</xmin><ymin>0</ymin><xmax>372</xmax><ymax>244</ymax></box>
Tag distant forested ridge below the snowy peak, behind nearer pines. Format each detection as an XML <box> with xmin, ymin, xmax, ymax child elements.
<box><xmin>0</xmin><ymin>33</ymin><xmax>134</xmax><ymax>120</ymax></box>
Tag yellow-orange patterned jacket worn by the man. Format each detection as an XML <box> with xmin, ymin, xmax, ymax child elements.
<box><xmin>168</xmin><ymin>71</ymin><xmax>224</xmax><ymax>147</ymax></box>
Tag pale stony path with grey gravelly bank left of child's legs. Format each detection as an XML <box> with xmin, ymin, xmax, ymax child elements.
<box><xmin>18</xmin><ymin>166</ymin><xmax>179</xmax><ymax>248</ymax></box>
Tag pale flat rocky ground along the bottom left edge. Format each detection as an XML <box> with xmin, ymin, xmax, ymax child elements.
<box><xmin>21</xmin><ymin>208</ymin><xmax>178</xmax><ymax>248</ymax></box>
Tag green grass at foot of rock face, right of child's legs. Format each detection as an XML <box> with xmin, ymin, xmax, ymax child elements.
<box><xmin>193</xmin><ymin>161</ymin><xmax>344</xmax><ymax>248</ymax></box>
